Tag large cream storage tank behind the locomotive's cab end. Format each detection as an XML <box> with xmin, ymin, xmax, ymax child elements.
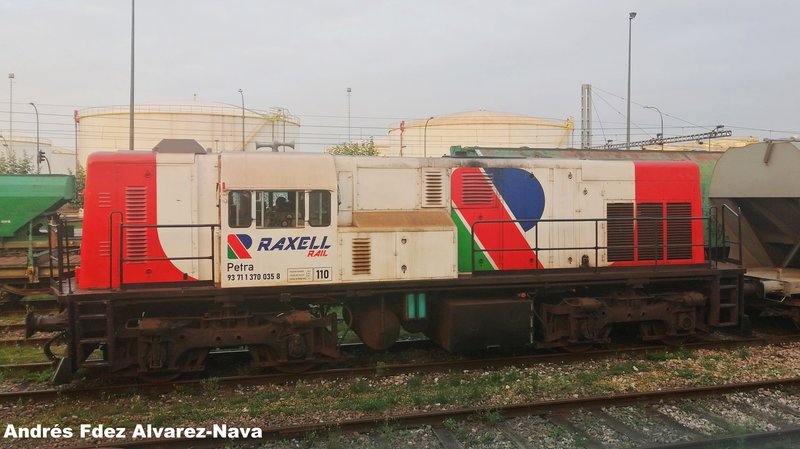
<box><xmin>76</xmin><ymin>101</ymin><xmax>300</xmax><ymax>165</ymax></box>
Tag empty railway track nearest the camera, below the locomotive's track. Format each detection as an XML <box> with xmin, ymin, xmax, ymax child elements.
<box><xmin>45</xmin><ymin>378</ymin><xmax>800</xmax><ymax>449</ymax></box>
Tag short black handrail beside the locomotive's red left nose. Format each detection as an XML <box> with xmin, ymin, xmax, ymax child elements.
<box><xmin>109</xmin><ymin>222</ymin><xmax>219</xmax><ymax>289</ymax></box>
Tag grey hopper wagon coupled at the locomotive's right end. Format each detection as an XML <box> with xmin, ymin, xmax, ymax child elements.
<box><xmin>710</xmin><ymin>140</ymin><xmax>800</xmax><ymax>326</ymax></box>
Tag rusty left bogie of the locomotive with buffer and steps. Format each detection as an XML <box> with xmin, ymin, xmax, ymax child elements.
<box><xmin>37</xmin><ymin>298</ymin><xmax>339</xmax><ymax>381</ymax></box>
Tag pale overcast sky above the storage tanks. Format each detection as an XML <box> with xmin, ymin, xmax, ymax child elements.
<box><xmin>0</xmin><ymin>0</ymin><xmax>800</xmax><ymax>148</ymax></box>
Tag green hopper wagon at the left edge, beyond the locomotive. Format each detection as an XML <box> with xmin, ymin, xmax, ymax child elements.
<box><xmin>0</xmin><ymin>175</ymin><xmax>76</xmax><ymax>300</ymax></box>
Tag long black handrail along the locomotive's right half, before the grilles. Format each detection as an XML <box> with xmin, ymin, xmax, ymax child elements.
<box><xmin>470</xmin><ymin>217</ymin><xmax>710</xmax><ymax>274</ymax></box>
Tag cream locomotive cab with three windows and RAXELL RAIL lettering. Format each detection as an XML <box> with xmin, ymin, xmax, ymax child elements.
<box><xmin>220</xmin><ymin>153</ymin><xmax>338</xmax><ymax>288</ymax></box>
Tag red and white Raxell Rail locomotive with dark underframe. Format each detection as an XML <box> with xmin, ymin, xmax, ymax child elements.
<box><xmin>29</xmin><ymin>143</ymin><xmax>741</xmax><ymax>379</ymax></box>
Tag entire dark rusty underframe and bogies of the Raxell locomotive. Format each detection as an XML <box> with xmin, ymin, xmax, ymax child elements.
<box><xmin>29</xmin><ymin>266</ymin><xmax>742</xmax><ymax>381</ymax></box>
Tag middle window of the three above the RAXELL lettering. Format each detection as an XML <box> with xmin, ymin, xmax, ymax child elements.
<box><xmin>255</xmin><ymin>190</ymin><xmax>306</xmax><ymax>228</ymax></box>
